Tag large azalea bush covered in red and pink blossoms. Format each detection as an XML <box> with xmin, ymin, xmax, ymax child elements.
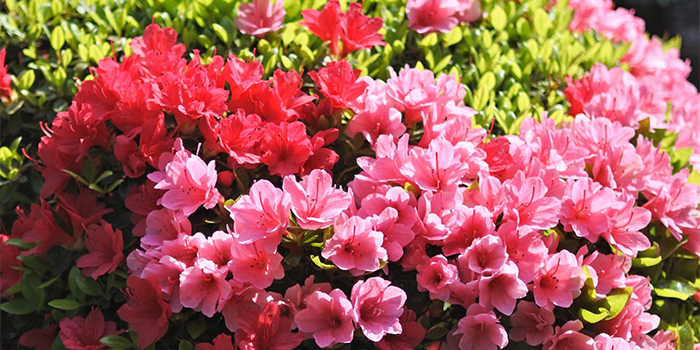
<box><xmin>0</xmin><ymin>0</ymin><xmax>700</xmax><ymax>350</ymax></box>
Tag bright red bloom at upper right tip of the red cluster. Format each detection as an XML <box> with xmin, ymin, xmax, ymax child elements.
<box><xmin>309</xmin><ymin>61</ymin><xmax>368</xmax><ymax>110</ymax></box>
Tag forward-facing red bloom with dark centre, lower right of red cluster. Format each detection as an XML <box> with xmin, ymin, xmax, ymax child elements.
<box><xmin>261</xmin><ymin>122</ymin><xmax>312</xmax><ymax>176</ymax></box>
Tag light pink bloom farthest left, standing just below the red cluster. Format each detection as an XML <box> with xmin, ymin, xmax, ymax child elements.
<box><xmin>148</xmin><ymin>142</ymin><xmax>221</xmax><ymax>216</ymax></box>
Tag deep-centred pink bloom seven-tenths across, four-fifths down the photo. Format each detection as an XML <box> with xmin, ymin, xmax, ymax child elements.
<box><xmin>478</xmin><ymin>261</ymin><xmax>527</xmax><ymax>315</ymax></box>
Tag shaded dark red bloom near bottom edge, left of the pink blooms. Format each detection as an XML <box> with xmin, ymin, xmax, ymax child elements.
<box><xmin>117</xmin><ymin>275</ymin><xmax>173</xmax><ymax>349</ymax></box>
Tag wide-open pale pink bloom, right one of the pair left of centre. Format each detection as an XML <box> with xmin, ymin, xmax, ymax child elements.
<box><xmin>283</xmin><ymin>169</ymin><xmax>352</xmax><ymax>230</ymax></box>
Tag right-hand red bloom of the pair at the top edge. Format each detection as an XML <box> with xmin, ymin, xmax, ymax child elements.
<box><xmin>340</xmin><ymin>2</ymin><xmax>386</xmax><ymax>57</ymax></box>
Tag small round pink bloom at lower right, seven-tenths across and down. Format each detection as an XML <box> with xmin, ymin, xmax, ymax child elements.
<box><xmin>459</xmin><ymin>235</ymin><xmax>508</xmax><ymax>274</ymax></box>
